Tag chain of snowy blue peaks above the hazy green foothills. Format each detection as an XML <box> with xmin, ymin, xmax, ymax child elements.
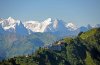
<box><xmin>0</xmin><ymin>17</ymin><xmax>100</xmax><ymax>36</ymax></box>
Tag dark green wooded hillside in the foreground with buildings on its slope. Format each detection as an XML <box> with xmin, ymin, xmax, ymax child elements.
<box><xmin>0</xmin><ymin>28</ymin><xmax>100</xmax><ymax>65</ymax></box>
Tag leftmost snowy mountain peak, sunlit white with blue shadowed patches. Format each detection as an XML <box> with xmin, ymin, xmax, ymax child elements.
<box><xmin>0</xmin><ymin>17</ymin><xmax>24</xmax><ymax>32</ymax></box>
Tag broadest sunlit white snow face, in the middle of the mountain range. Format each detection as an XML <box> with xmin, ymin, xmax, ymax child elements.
<box><xmin>24</xmin><ymin>18</ymin><xmax>52</xmax><ymax>32</ymax></box>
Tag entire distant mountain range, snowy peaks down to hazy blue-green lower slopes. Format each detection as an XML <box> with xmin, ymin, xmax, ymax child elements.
<box><xmin>0</xmin><ymin>17</ymin><xmax>100</xmax><ymax>59</ymax></box>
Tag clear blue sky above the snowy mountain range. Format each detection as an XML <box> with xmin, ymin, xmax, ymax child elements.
<box><xmin>0</xmin><ymin>0</ymin><xmax>100</xmax><ymax>26</ymax></box>
